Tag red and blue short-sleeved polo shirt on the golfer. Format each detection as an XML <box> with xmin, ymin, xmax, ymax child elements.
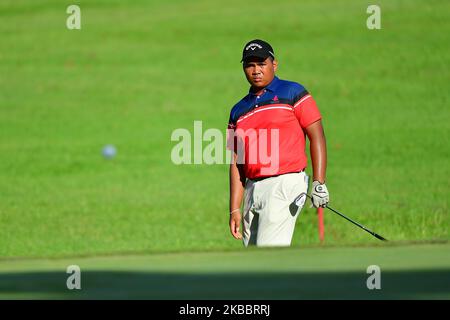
<box><xmin>227</xmin><ymin>77</ymin><xmax>321</xmax><ymax>179</ymax></box>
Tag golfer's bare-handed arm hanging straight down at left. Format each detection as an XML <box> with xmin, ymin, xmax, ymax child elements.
<box><xmin>230</xmin><ymin>154</ymin><xmax>245</xmax><ymax>239</ymax></box>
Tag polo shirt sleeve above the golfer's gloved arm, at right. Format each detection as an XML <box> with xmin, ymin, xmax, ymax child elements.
<box><xmin>292</xmin><ymin>85</ymin><xmax>322</xmax><ymax>129</ymax></box>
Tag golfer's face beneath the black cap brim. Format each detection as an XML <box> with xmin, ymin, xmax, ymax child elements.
<box><xmin>243</xmin><ymin>57</ymin><xmax>277</xmax><ymax>88</ymax></box>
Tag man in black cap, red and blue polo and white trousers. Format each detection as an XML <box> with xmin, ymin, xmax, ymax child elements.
<box><xmin>227</xmin><ymin>39</ymin><xmax>329</xmax><ymax>246</ymax></box>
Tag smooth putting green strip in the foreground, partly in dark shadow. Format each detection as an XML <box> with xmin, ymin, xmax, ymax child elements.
<box><xmin>0</xmin><ymin>244</ymin><xmax>450</xmax><ymax>299</ymax></box>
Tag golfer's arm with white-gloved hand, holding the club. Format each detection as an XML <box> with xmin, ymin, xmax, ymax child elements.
<box><xmin>306</xmin><ymin>120</ymin><xmax>330</xmax><ymax>208</ymax></box>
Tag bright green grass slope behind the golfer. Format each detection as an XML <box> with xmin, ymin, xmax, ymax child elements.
<box><xmin>0</xmin><ymin>0</ymin><xmax>450</xmax><ymax>257</ymax></box>
